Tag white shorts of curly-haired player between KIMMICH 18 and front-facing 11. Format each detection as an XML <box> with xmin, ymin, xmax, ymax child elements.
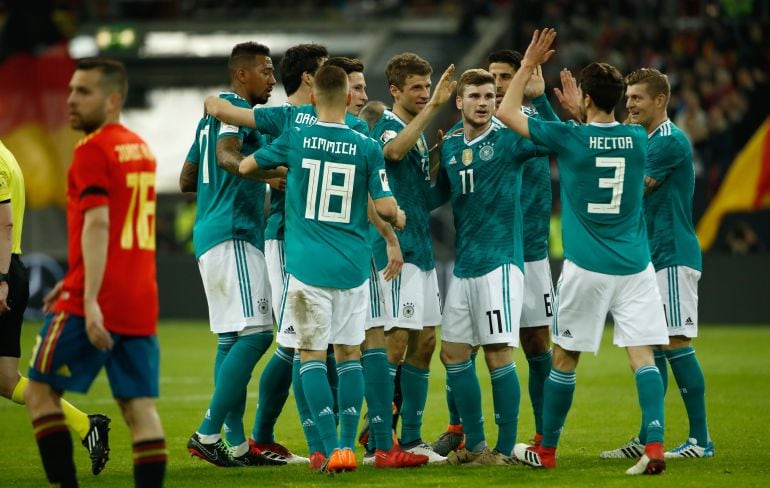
<box><xmin>382</xmin><ymin>263</ymin><xmax>441</xmax><ymax>331</ymax></box>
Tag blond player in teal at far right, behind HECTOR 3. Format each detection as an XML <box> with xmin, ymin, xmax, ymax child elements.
<box><xmin>601</xmin><ymin>68</ymin><xmax>714</xmax><ymax>458</ymax></box>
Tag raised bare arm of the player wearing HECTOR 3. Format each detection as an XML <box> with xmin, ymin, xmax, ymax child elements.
<box><xmin>497</xmin><ymin>29</ymin><xmax>556</xmax><ymax>139</ymax></box>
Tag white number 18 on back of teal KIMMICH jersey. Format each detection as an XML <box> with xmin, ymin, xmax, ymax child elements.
<box><xmin>302</xmin><ymin>158</ymin><xmax>356</xmax><ymax>224</ymax></box>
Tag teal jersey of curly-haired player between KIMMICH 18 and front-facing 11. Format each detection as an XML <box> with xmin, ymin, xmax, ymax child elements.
<box><xmin>371</xmin><ymin>110</ymin><xmax>434</xmax><ymax>271</ymax></box>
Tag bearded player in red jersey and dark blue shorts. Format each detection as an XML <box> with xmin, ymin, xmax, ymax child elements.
<box><xmin>25</xmin><ymin>58</ymin><xmax>167</xmax><ymax>487</ymax></box>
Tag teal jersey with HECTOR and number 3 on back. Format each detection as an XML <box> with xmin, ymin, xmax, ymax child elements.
<box><xmin>529</xmin><ymin>118</ymin><xmax>650</xmax><ymax>275</ymax></box>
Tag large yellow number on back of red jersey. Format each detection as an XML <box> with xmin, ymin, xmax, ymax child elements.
<box><xmin>120</xmin><ymin>171</ymin><xmax>155</xmax><ymax>251</ymax></box>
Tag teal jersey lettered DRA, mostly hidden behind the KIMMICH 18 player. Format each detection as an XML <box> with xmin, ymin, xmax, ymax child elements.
<box><xmin>254</xmin><ymin>103</ymin><xmax>369</xmax><ymax>240</ymax></box>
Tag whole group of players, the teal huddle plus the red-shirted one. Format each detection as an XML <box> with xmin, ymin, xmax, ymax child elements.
<box><xmin>9</xmin><ymin>20</ymin><xmax>714</xmax><ymax>486</ymax></box>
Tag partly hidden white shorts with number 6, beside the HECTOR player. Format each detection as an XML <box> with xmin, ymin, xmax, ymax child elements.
<box><xmin>519</xmin><ymin>258</ymin><xmax>556</xmax><ymax>329</ymax></box>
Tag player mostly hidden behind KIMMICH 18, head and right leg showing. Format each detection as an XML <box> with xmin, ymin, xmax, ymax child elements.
<box><xmin>326</xmin><ymin>56</ymin><xmax>428</xmax><ymax>468</ymax></box>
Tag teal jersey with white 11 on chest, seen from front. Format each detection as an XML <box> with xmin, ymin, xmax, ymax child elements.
<box><xmin>434</xmin><ymin>123</ymin><xmax>538</xmax><ymax>278</ymax></box>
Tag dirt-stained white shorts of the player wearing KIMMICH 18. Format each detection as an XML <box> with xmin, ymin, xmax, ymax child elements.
<box><xmin>278</xmin><ymin>274</ymin><xmax>369</xmax><ymax>351</ymax></box>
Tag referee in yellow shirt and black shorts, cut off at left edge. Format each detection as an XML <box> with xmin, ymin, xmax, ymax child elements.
<box><xmin>0</xmin><ymin>141</ymin><xmax>110</xmax><ymax>474</ymax></box>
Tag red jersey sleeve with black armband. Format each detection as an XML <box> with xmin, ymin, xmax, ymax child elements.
<box><xmin>71</xmin><ymin>144</ymin><xmax>110</xmax><ymax>212</ymax></box>
